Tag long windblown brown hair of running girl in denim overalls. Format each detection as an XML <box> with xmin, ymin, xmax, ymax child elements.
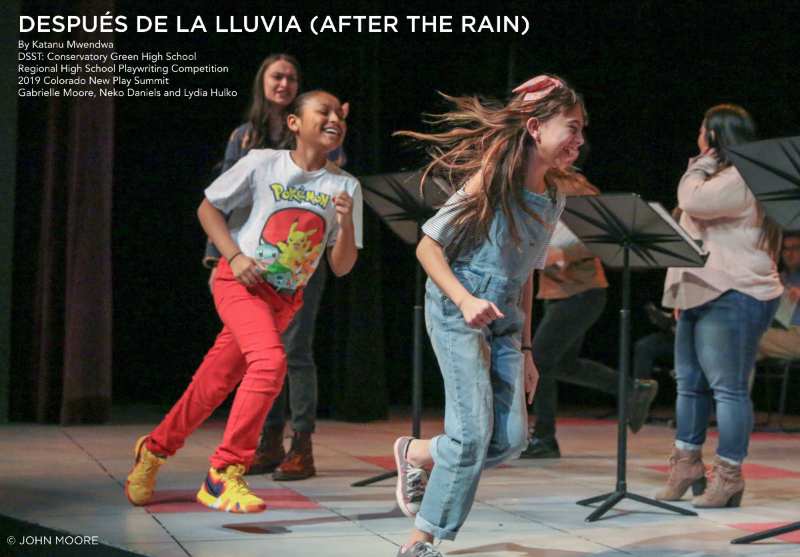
<box><xmin>394</xmin><ymin>76</ymin><xmax>586</xmax><ymax>259</ymax></box>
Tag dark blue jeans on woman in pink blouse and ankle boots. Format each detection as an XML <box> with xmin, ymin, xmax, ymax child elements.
<box><xmin>675</xmin><ymin>290</ymin><xmax>778</xmax><ymax>463</ymax></box>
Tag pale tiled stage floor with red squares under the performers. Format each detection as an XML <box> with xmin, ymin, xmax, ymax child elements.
<box><xmin>0</xmin><ymin>408</ymin><xmax>800</xmax><ymax>557</ymax></box>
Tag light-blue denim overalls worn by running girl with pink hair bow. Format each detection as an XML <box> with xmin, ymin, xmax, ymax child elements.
<box><xmin>415</xmin><ymin>190</ymin><xmax>564</xmax><ymax>540</ymax></box>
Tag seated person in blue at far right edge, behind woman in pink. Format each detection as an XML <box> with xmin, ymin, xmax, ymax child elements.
<box><xmin>758</xmin><ymin>231</ymin><xmax>800</xmax><ymax>360</ymax></box>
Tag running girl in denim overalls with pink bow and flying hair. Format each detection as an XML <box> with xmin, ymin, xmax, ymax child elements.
<box><xmin>394</xmin><ymin>75</ymin><xmax>586</xmax><ymax>557</ymax></box>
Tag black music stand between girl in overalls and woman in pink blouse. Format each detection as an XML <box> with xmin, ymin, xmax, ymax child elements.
<box><xmin>561</xmin><ymin>193</ymin><xmax>706</xmax><ymax>522</ymax></box>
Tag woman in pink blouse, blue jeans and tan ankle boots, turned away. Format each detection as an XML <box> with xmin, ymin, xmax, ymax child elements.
<box><xmin>656</xmin><ymin>104</ymin><xmax>783</xmax><ymax>508</ymax></box>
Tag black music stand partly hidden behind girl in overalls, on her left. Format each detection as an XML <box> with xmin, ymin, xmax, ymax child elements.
<box><xmin>351</xmin><ymin>170</ymin><xmax>448</xmax><ymax>487</ymax></box>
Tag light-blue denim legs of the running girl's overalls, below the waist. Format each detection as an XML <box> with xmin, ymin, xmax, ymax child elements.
<box><xmin>414</xmin><ymin>280</ymin><xmax>528</xmax><ymax>540</ymax></box>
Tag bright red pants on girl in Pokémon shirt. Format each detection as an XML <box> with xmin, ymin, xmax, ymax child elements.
<box><xmin>147</xmin><ymin>259</ymin><xmax>303</xmax><ymax>468</ymax></box>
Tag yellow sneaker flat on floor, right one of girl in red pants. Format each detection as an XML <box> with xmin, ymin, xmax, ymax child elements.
<box><xmin>197</xmin><ymin>464</ymin><xmax>267</xmax><ymax>513</ymax></box>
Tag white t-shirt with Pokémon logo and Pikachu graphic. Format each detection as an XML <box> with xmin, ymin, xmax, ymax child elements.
<box><xmin>205</xmin><ymin>149</ymin><xmax>363</xmax><ymax>290</ymax></box>
